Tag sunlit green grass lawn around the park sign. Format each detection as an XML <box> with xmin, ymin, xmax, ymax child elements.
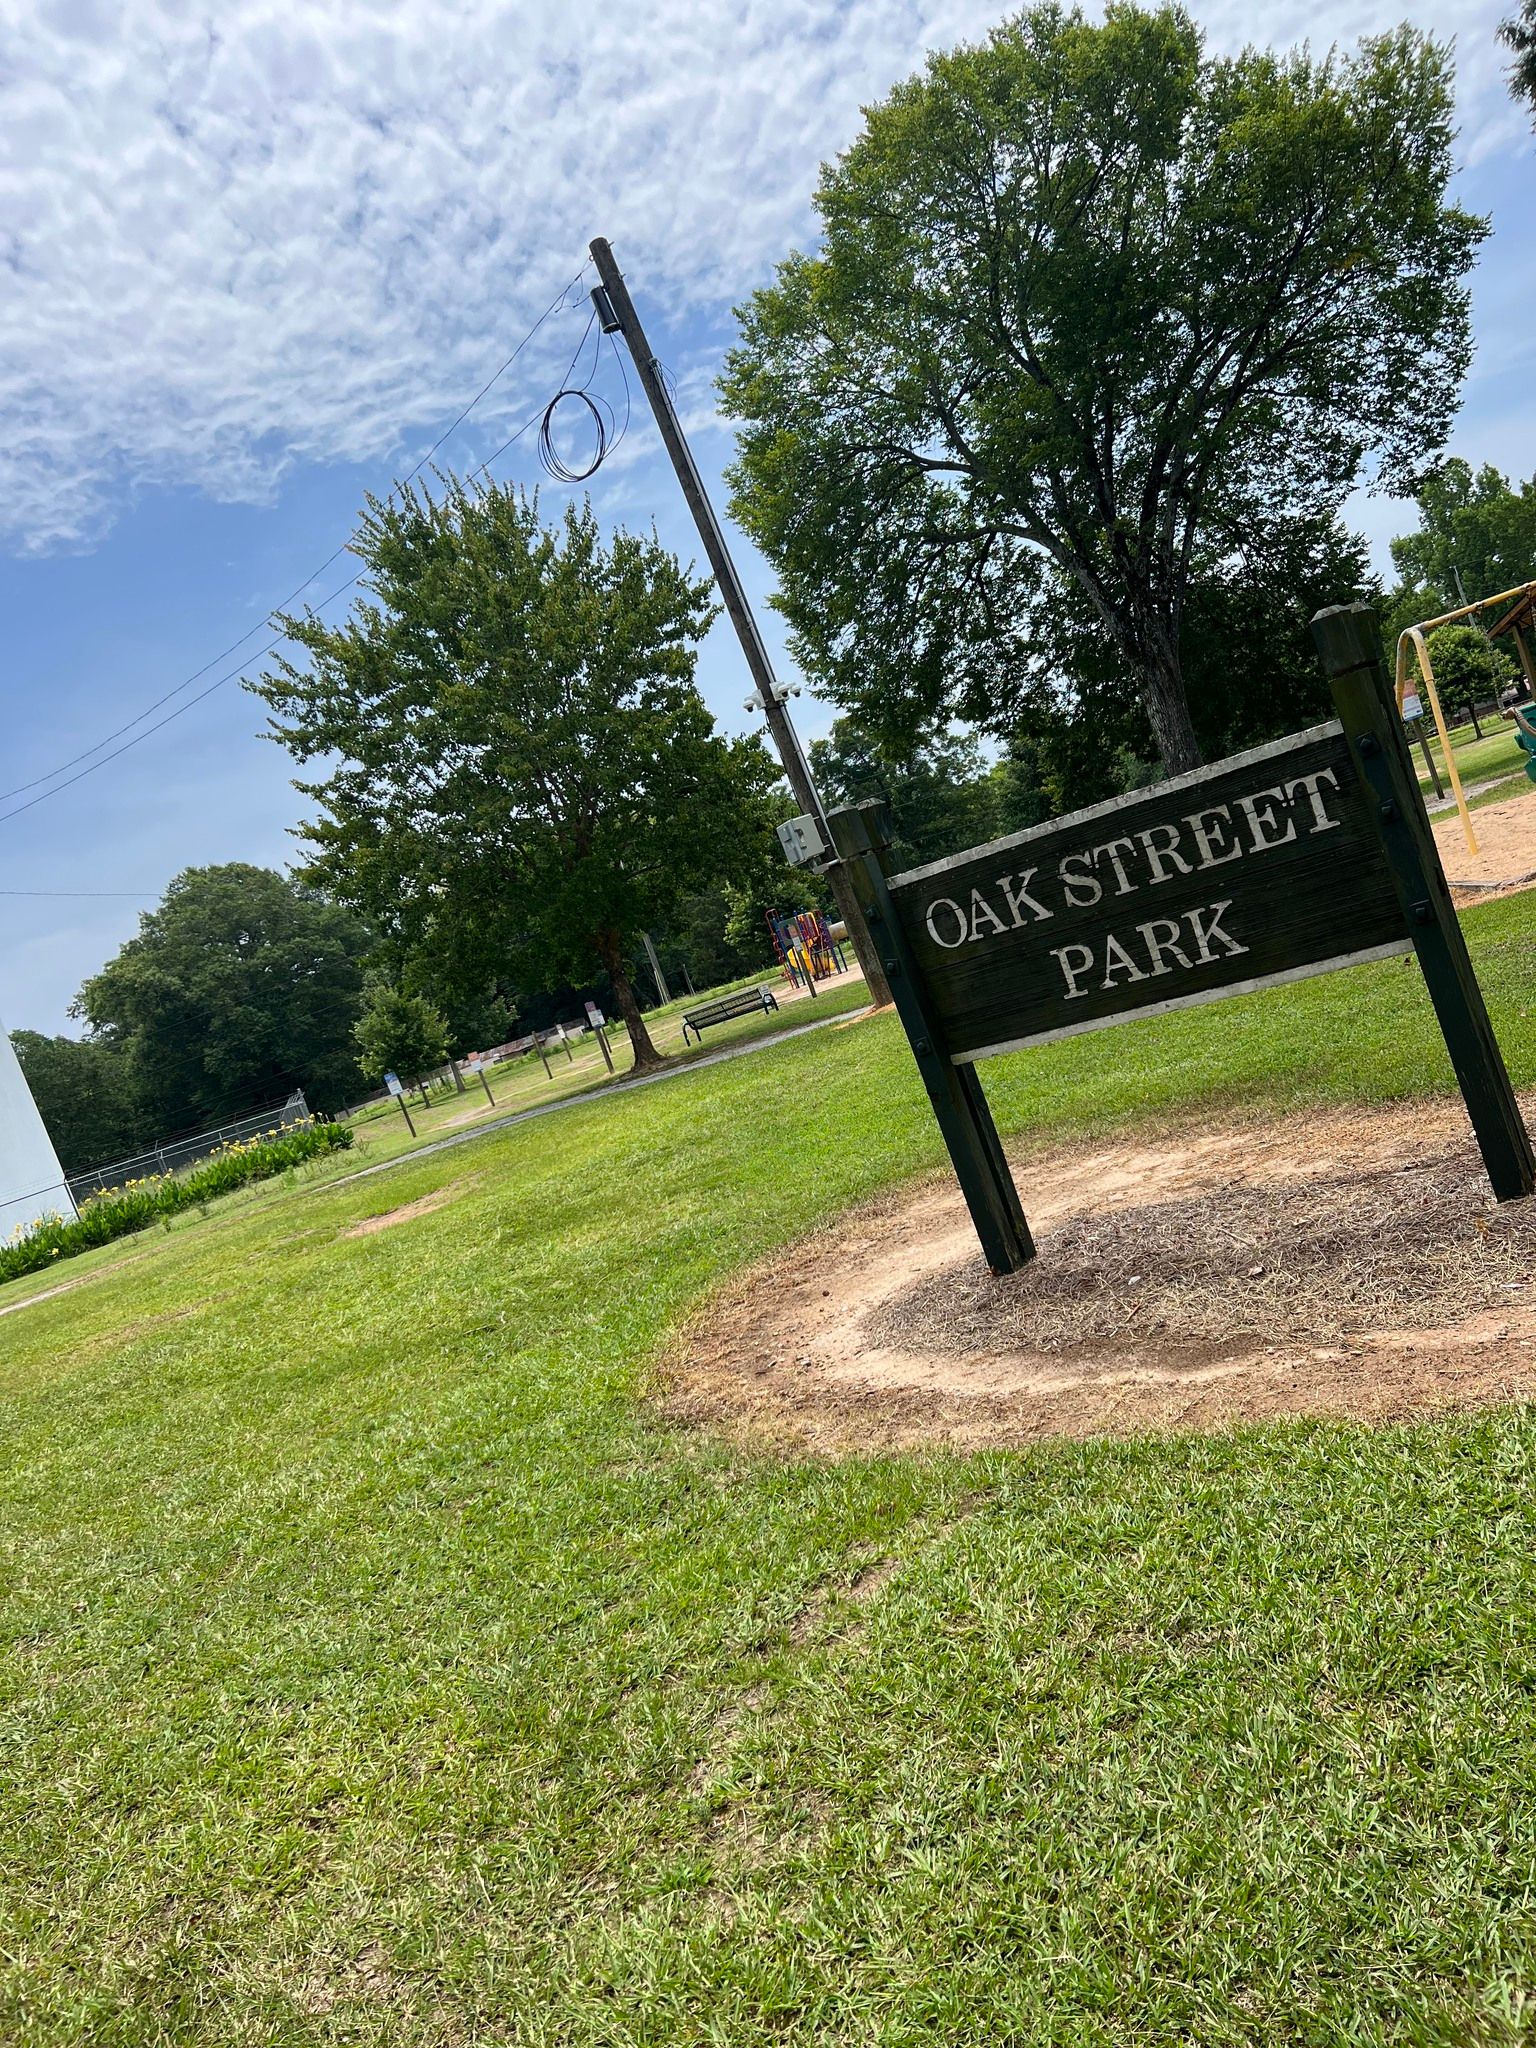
<box><xmin>0</xmin><ymin>897</ymin><xmax>1536</xmax><ymax>2048</ymax></box>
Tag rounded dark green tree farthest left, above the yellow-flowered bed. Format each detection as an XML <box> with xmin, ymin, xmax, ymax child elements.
<box><xmin>74</xmin><ymin>862</ymin><xmax>367</xmax><ymax>1135</ymax></box>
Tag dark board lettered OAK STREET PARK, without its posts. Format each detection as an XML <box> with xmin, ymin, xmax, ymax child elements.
<box><xmin>891</xmin><ymin>721</ymin><xmax>1413</xmax><ymax>1061</ymax></box>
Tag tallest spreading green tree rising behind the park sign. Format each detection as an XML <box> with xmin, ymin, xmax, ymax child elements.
<box><xmin>723</xmin><ymin>4</ymin><xmax>1485</xmax><ymax>770</ymax></box>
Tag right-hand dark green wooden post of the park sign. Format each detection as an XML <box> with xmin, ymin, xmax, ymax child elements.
<box><xmin>1313</xmin><ymin>604</ymin><xmax>1536</xmax><ymax>1202</ymax></box>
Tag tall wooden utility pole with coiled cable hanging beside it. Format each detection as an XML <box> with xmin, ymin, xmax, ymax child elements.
<box><xmin>590</xmin><ymin>236</ymin><xmax>891</xmax><ymax>1004</ymax></box>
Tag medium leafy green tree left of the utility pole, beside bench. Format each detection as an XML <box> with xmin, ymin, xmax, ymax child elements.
<box><xmin>256</xmin><ymin>481</ymin><xmax>774</xmax><ymax>1067</ymax></box>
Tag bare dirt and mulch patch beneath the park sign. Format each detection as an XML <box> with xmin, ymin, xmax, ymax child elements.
<box><xmin>664</xmin><ymin>1104</ymin><xmax>1536</xmax><ymax>1454</ymax></box>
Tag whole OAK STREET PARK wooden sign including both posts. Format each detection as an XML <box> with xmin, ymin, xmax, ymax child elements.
<box><xmin>827</xmin><ymin>606</ymin><xmax>1536</xmax><ymax>1274</ymax></box>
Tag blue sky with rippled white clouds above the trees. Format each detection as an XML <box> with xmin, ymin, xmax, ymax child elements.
<box><xmin>0</xmin><ymin>0</ymin><xmax>1536</xmax><ymax>1030</ymax></box>
